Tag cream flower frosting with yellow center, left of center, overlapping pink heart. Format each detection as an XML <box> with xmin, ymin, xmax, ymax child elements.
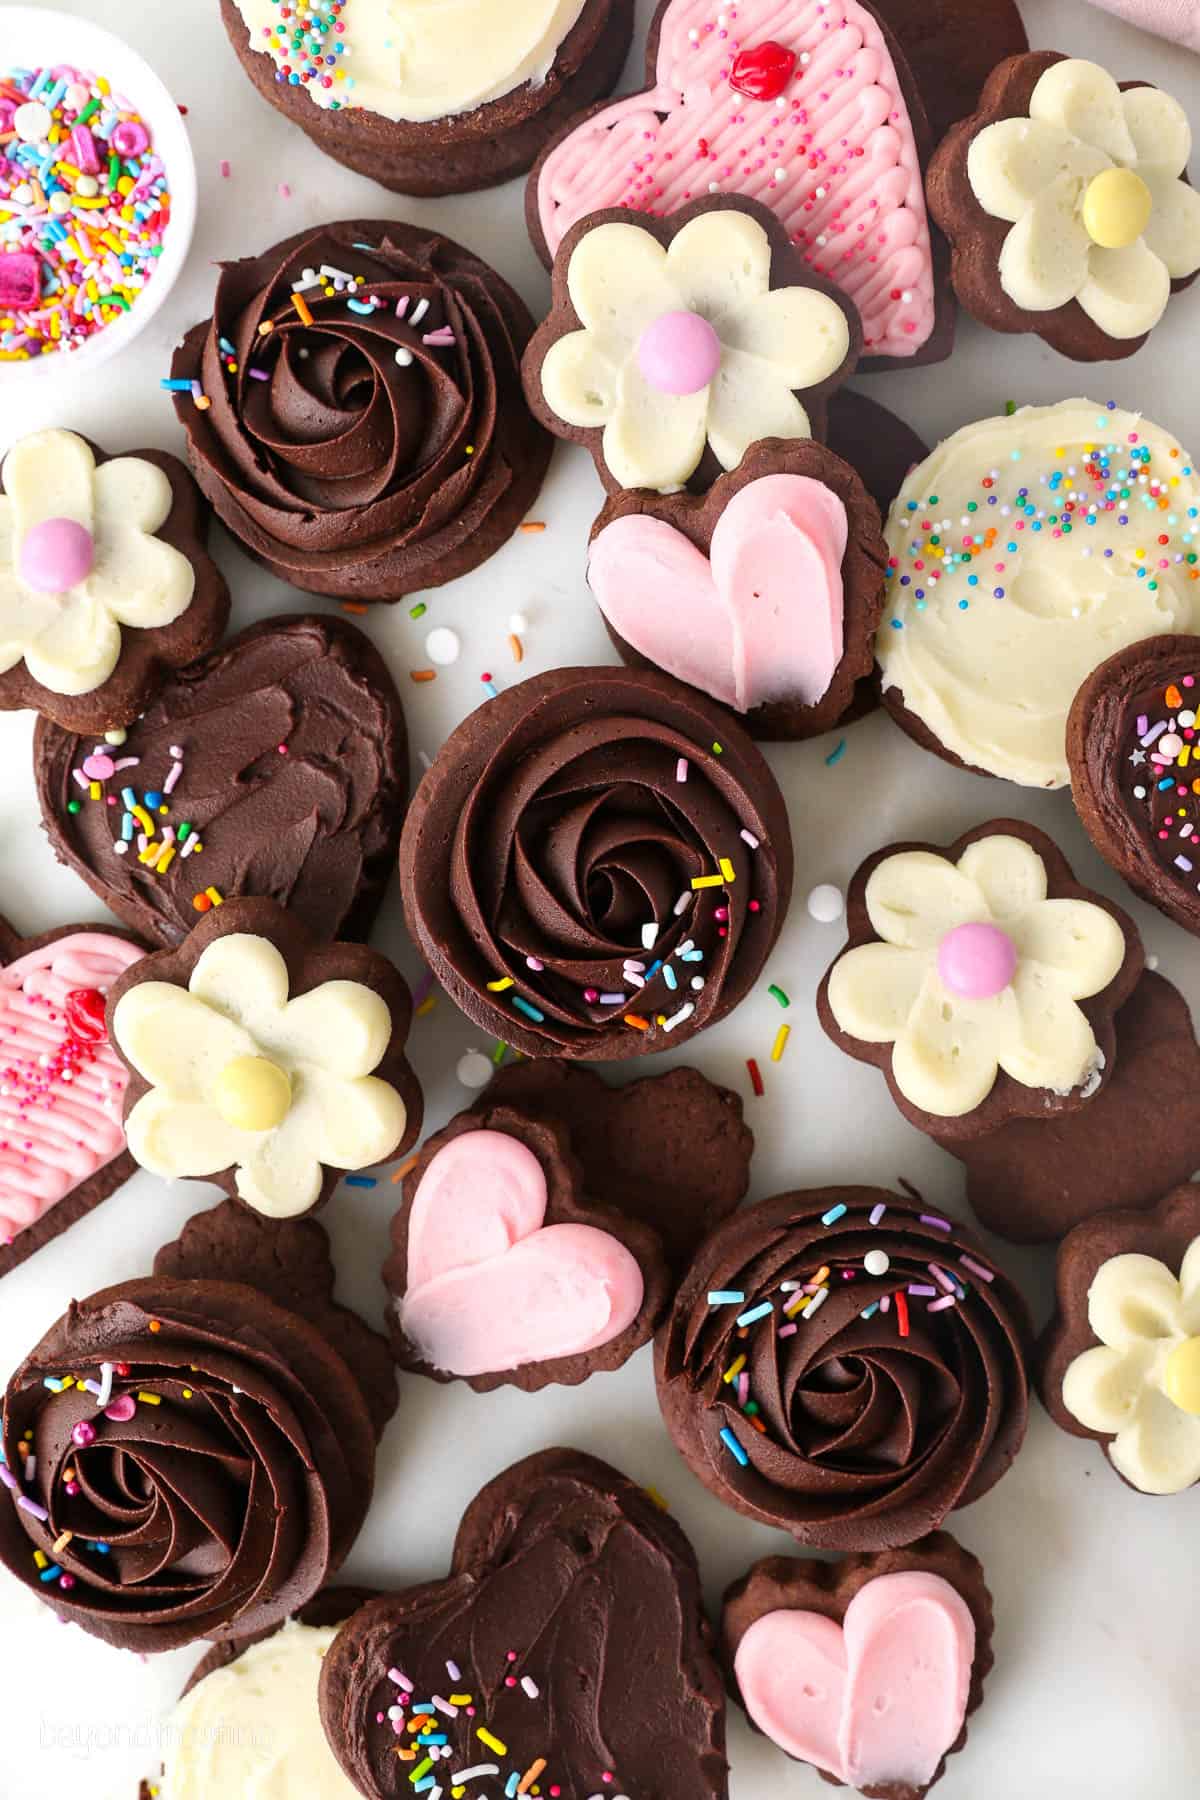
<box><xmin>113</xmin><ymin>932</ymin><xmax>407</xmax><ymax>1219</ymax></box>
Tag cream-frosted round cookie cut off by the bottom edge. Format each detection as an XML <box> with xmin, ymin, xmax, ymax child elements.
<box><xmin>152</xmin><ymin>1588</ymin><xmax>374</xmax><ymax>1800</ymax></box>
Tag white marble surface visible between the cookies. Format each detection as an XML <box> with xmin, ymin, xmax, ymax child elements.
<box><xmin>0</xmin><ymin>0</ymin><xmax>1200</xmax><ymax>1800</ymax></box>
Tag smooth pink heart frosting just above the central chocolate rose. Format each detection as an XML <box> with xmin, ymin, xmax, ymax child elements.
<box><xmin>588</xmin><ymin>475</ymin><xmax>847</xmax><ymax>713</ymax></box>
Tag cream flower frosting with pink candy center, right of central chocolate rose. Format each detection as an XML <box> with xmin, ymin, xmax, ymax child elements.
<box><xmin>828</xmin><ymin>832</ymin><xmax>1126</xmax><ymax>1118</ymax></box>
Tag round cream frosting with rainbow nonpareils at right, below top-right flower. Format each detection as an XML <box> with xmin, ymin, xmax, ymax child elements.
<box><xmin>876</xmin><ymin>400</ymin><xmax>1200</xmax><ymax>788</ymax></box>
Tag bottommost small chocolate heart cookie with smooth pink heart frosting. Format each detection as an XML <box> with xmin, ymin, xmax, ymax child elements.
<box><xmin>721</xmin><ymin>1532</ymin><xmax>995</xmax><ymax>1800</ymax></box>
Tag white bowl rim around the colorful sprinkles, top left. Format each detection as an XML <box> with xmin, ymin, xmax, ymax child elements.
<box><xmin>0</xmin><ymin>5</ymin><xmax>196</xmax><ymax>389</ymax></box>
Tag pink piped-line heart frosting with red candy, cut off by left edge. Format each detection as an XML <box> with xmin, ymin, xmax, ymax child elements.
<box><xmin>0</xmin><ymin>931</ymin><xmax>144</xmax><ymax>1240</ymax></box>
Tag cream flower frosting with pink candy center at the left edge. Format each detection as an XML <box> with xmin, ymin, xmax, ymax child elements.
<box><xmin>0</xmin><ymin>430</ymin><xmax>196</xmax><ymax>695</ymax></box>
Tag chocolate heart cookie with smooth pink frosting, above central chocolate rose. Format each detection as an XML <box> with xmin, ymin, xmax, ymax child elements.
<box><xmin>588</xmin><ymin>439</ymin><xmax>887</xmax><ymax>738</ymax></box>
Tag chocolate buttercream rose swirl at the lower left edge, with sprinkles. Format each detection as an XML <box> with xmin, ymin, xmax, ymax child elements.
<box><xmin>0</xmin><ymin>1276</ymin><xmax>374</xmax><ymax>1651</ymax></box>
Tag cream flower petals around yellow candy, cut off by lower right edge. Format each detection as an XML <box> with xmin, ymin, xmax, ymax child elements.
<box><xmin>1061</xmin><ymin>1237</ymin><xmax>1200</xmax><ymax>1494</ymax></box>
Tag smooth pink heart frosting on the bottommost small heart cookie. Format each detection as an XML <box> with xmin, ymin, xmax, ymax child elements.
<box><xmin>734</xmin><ymin>1570</ymin><xmax>975</xmax><ymax>1787</ymax></box>
